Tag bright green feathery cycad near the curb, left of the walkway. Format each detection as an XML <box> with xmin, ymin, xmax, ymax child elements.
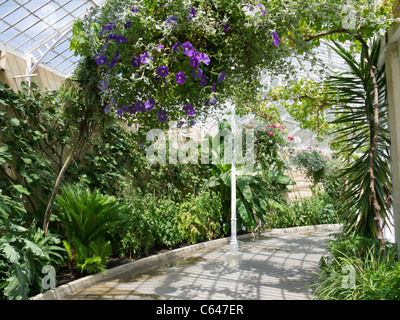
<box><xmin>57</xmin><ymin>185</ymin><xmax>127</xmax><ymax>273</ymax></box>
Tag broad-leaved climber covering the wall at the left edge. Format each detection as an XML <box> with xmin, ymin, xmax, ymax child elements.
<box><xmin>0</xmin><ymin>82</ymin><xmax>70</xmax><ymax>221</ymax></box>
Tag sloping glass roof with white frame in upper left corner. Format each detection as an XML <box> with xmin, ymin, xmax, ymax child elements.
<box><xmin>0</xmin><ymin>0</ymin><xmax>105</xmax><ymax>77</ymax></box>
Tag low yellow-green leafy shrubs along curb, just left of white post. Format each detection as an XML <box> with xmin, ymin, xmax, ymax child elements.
<box><xmin>120</xmin><ymin>192</ymin><xmax>222</xmax><ymax>258</ymax></box>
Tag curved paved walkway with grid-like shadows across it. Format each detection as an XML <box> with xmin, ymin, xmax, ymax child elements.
<box><xmin>63</xmin><ymin>231</ymin><xmax>335</xmax><ymax>300</ymax></box>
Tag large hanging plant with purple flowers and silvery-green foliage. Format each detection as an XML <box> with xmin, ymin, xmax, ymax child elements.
<box><xmin>69</xmin><ymin>0</ymin><xmax>296</xmax><ymax>128</ymax></box>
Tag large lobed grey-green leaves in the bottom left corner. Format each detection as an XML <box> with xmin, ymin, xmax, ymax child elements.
<box><xmin>0</xmin><ymin>223</ymin><xmax>63</xmax><ymax>300</ymax></box>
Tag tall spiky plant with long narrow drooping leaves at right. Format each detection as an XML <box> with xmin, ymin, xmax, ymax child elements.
<box><xmin>329</xmin><ymin>42</ymin><xmax>392</xmax><ymax>251</ymax></box>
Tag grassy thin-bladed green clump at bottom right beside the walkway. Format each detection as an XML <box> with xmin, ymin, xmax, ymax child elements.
<box><xmin>315</xmin><ymin>235</ymin><xmax>400</xmax><ymax>300</ymax></box>
